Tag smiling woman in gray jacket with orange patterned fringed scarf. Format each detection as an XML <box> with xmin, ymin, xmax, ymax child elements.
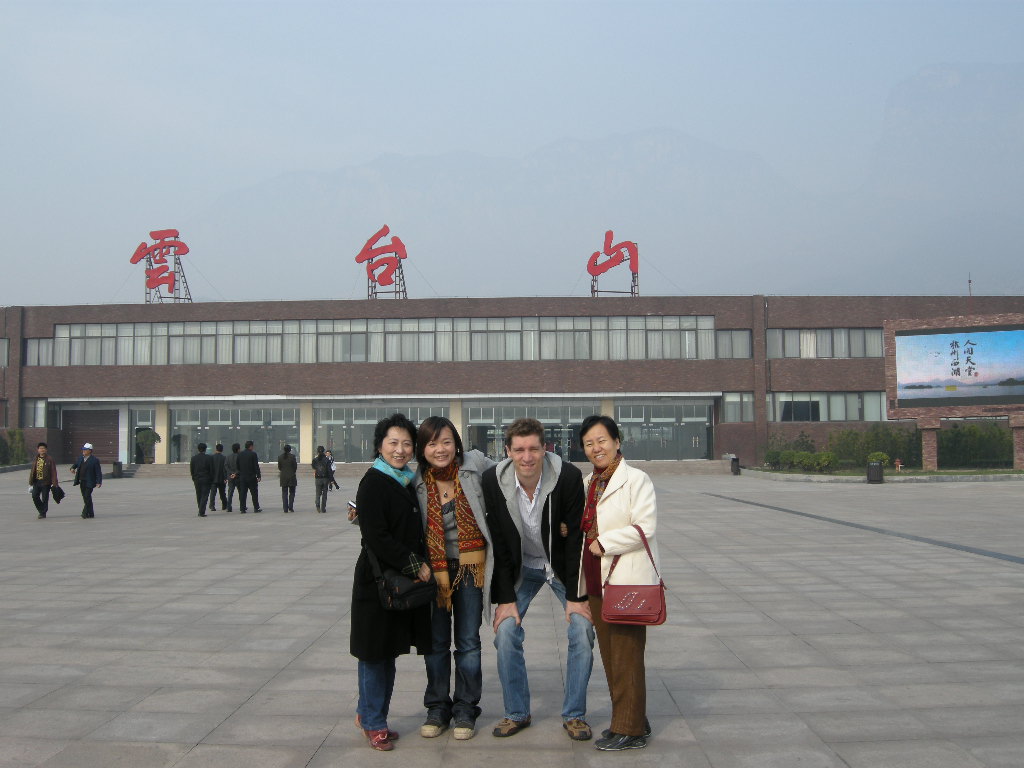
<box><xmin>414</xmin><ymin>416</ymin><xmax>494</xmax><ymax>739</ymax></box>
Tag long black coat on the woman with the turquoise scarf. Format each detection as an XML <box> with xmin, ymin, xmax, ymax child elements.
<box><xmin>349</xmin><ymin>468</ymin><xmax>430</xmax><ymax>662</ymax></box>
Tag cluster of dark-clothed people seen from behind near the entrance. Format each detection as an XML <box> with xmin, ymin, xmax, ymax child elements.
<box><xmin>188</xmin><ymin>440</ymin><xmax>341</xmax><ymax>517</ymax></box>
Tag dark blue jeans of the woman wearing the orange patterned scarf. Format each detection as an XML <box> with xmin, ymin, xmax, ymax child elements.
<box><xmin>423</xmin><ymin>570</ymin><xmax>483</xmax><ymax>723</ymax></box>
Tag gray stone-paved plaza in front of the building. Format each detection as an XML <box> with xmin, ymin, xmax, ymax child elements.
<box><xmin>0</xmin><ymin>465</ymin><xmax>1024</xmax><ymax>768</ymax></box>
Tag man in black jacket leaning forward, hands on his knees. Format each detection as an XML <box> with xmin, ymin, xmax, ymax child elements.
<box><xmin>482</xmin><ymin>419</ymin><xmax>594</xmax><ymax>741</ymax></box>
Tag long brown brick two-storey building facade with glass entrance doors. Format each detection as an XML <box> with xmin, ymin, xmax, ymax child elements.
<box><xmin>0</xmin><ymin>296</ymin><xmax>1024</xmax><ymax>465</ymax></box>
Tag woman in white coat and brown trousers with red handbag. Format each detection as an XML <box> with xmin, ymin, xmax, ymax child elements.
<box><xmin>580</xmin><ymin>416</ymin><xmax>658</xmax><ymax>752</ymax></box>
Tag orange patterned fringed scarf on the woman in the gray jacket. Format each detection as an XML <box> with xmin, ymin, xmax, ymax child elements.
<box><xmin>423</xmin><ymin>462</ymin><xmax>487</xmax><ymax>610</ymax></box>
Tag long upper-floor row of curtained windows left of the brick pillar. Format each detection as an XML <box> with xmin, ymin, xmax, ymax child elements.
<box><xmin>16</xmin><ymin>315</ymin><xmax>751</xmax><ymax>366</ymax></box>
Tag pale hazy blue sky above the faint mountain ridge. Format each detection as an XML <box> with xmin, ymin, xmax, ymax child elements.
<box><xmin>0</xmin><ymin>0</ymin><xmax>1024</xmax><ymax>305</ymax></box>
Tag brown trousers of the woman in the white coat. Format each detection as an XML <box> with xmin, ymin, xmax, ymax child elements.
<box><xmin>589</xmin><ymin>595</ymin><xmax>647</xmax><ymax>736</ymax></box>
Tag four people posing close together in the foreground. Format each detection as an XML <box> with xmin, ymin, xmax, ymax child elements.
<box><xmin>349</xmin><ymin>414</ymin><xmax>658</xmax><ymax>752</ymax></box>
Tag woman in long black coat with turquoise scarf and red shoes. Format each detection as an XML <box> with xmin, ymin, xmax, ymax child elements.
<box><xmin>349</xmin><ymin>414</ymin><xmax>431</xmax><ymax>752</ymax></box>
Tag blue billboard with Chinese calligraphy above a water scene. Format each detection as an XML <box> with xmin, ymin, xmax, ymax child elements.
<box><xmin>894</xmin><ymin>325</ymin><xmax>1024</xmax><ymax>411</ymax></box>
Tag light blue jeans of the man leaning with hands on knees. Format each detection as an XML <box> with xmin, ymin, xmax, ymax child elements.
<box><xmin>495</xmin><ymin>567</ymin><xmax>594</xmax><ymax>720</ymax></box>
